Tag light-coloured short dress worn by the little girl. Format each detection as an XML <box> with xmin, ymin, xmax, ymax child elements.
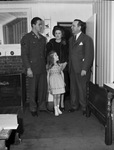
<box><xmin>48</xmin><ymin>64</ymin><xmax>65</xmax><ymax>94</ymax></box>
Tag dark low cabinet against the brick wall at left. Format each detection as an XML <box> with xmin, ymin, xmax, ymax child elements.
<box><xmin>0</xmin><ymin>73</ymin><xmax>26</xmax><ymax>109</ymax></box>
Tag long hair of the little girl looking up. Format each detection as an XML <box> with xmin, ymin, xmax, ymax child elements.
<box><xmin>47</xmin><ymin>51</ymin><xmax>56</xmax><ymax>69</ymax></box>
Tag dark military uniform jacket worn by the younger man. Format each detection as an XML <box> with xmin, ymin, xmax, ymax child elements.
<box><xmin>21</xmin><ymin>31</ymin><xmax>46</xmax><ymax>74</ymax></box>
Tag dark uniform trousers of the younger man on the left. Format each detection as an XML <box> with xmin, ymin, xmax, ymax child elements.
<box><xmin>28</xmin><ymin>73</ymin><xmax>47</xmax><ymax>111</ymax></box>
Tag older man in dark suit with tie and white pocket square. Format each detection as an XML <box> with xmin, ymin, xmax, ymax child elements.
<box><xmin>69</xmin><ymin>19</ymin><xmax>94</xmax><ymax>114</ymax></box>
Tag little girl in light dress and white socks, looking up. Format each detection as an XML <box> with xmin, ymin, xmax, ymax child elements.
<box><xmin>47</xmin><ymin>51</ymin><xmax>67</xmax><ymax>116</ymax></box>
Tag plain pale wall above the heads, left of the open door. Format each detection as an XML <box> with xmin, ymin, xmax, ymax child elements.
<box><xmin>32</xmin><ymin>3</ymin><xmax>92</xmax><ymax>36</ymax></box>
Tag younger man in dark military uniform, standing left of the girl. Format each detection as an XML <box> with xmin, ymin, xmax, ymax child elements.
<box><xmin>21</xmin><ymin>17</ymin><xmax>47</xmax><ymax>116</ymax></box>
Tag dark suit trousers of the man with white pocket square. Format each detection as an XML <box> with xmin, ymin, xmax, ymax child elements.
<box><xmin>70</xmin><ymin>69</ymin><xmax>90</xmax><ymax>109</ymax></box>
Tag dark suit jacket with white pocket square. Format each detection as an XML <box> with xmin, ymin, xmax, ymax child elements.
<box><xmin>69</xmin><ymin>33</ymin><xmax>94</xmax><ymax>73</ymax></box>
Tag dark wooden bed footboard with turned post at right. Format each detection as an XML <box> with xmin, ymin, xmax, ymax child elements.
<box><xmin>87</xmin><ymin>82</ymin><xmax>114</xmax><ymax>145</ymax></box>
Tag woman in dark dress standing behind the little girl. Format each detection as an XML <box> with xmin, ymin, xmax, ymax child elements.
<box><xmin>46</xmin><ymin>26</ymin><xmax>69</xmax><ymax>110</ymax></box>
